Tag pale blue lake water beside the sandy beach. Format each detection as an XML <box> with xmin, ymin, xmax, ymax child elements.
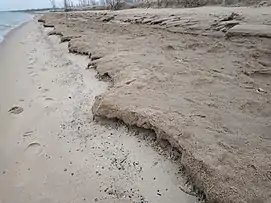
<box><xmin>0</xmin><ymin>12</ymin><xmax>32</xmax><ymax>42</ymax></box>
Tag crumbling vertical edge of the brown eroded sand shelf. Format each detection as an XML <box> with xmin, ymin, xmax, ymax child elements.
<box><xmin>39</xmin><ymin>18</ymin><xmax>249</xmax><ymax>203</ymax></box>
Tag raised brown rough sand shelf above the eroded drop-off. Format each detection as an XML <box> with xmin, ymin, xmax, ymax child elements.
<box><xmin>41</xmin><ymin>7</ymin><xmax>271</xmax><ymax>203</ymax></box>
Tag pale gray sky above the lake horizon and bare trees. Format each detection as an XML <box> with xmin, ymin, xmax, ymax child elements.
<box><xmin>0</xmin><ymin>0</ymin><xmax>62</xmax><ymax>11</ymax></box>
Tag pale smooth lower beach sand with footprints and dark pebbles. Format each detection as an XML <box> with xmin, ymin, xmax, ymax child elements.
<box><xmin>0</xmin><ymin>22</ymin><xmax>200</xmax><ymax>203</ymax></box>
